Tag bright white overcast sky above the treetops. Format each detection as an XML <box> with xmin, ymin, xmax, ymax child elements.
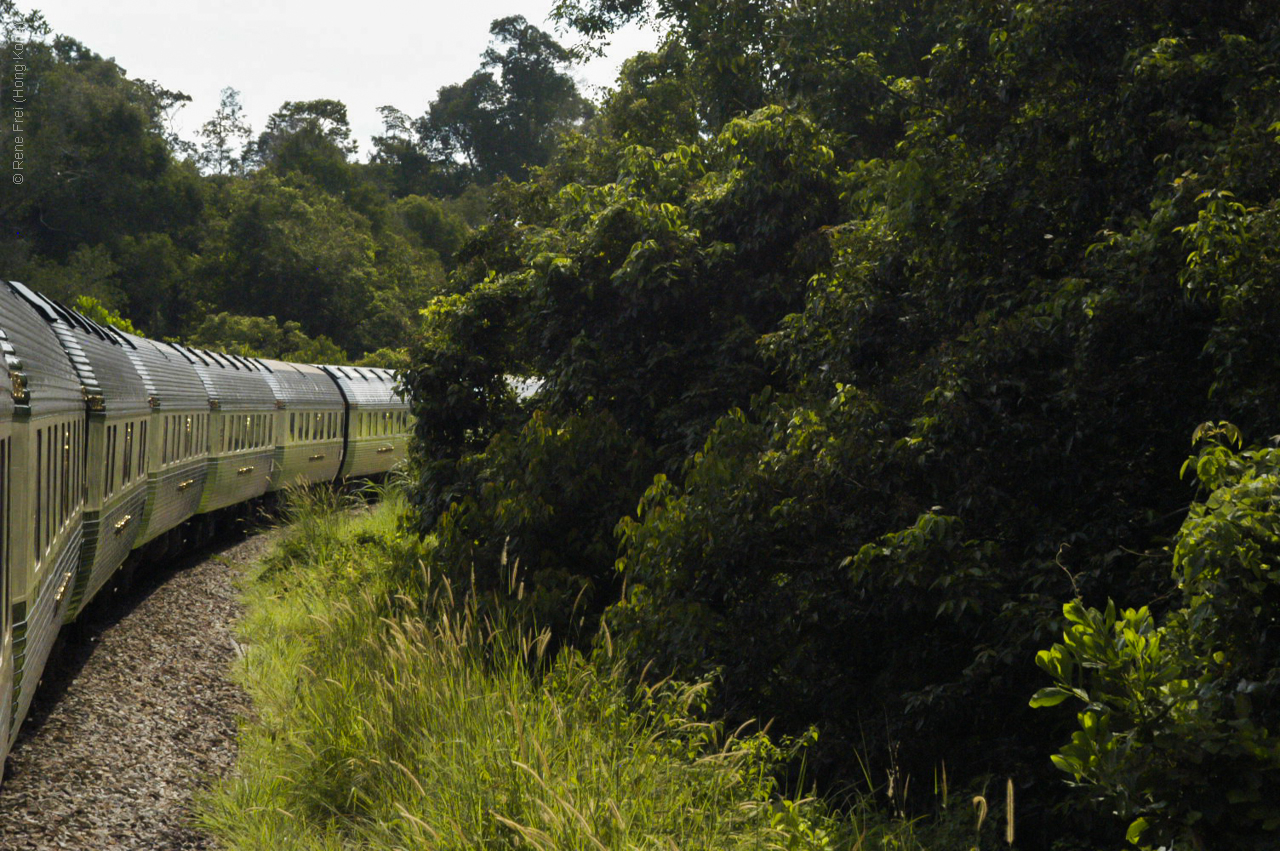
<box><xmin>32</xmin><ymin>0</ymin><xmax>658</xmax><ymax>160</ymax></box>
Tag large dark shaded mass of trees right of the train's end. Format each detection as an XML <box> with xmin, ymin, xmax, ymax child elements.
<box><xmin>412</xmin><ymin>0</ymin><xmax>1280</xmax><ymax>847</ymax></box>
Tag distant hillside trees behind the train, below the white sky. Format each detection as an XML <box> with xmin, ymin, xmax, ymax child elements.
<box><xmin>0</xmin><ymin>0</ymin><xmax>590</xmax><ymax>365</ymax></box>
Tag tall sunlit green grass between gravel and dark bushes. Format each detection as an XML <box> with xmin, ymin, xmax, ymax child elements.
<box><xmin>201</xmin><ymin>494</ymin><xmax>989</xmax><ymax>851</ymax></box>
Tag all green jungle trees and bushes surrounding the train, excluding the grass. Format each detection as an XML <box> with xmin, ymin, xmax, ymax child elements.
<box><xmin>0</xmin><ymin>0</ymin><xmax>1280</xmax><ymax>848</ymax></box>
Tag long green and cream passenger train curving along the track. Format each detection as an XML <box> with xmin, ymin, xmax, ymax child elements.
<box><xmin>0</xmin><ymin>282</ymin><xmax>411</xmax><ymax>778</ymax></box>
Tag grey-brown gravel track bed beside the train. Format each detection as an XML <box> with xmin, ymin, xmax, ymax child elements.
<box><xmin>0</xmin><ymin>535</ymin><xmax>270</xmax><ymax>851</ymax></box>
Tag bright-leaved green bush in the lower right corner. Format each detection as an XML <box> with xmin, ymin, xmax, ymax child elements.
<box><xmin>1033</xmin><ymin>433</ymin><xmax>1280</xmax><ymax>848</ymax></box>
